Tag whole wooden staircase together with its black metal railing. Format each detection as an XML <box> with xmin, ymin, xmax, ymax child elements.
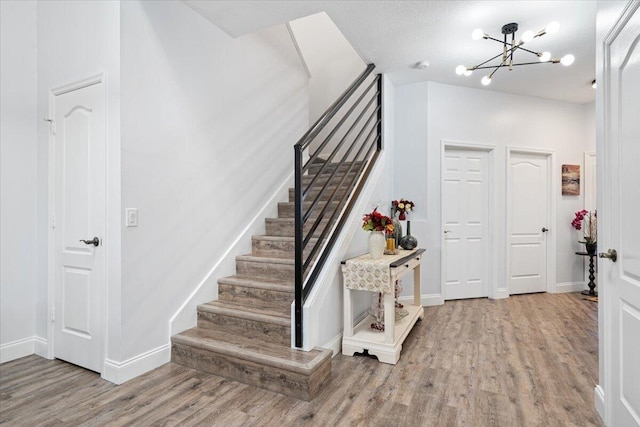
<box><xmin>171</xmin><ymin>64</ymin><xmax>382</xmax><ymax>400</ymax></box>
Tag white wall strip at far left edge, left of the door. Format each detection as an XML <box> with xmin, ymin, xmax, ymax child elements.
<box><xmin>0</xmin><ymin>1</ymin><xmax>38</xmax><ymax>363</ymax></box>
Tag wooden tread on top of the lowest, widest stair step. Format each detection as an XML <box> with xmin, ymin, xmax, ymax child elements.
<box><xmin>172</xmin><ymin>327</ymin><xmax>331</xmax><ymax>375</ymax></box>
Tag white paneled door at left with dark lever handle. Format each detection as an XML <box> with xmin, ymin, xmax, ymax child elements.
<box><xmin>51</xmin><ymin>79</ymin><xmax>105</xmax><ymax>372</ymax></box>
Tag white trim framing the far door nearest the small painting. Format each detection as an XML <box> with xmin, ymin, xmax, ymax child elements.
<box><xmin>504</xmin><ymin>145</ymin><xmax>560</xmax><ymax>293</ymax></box>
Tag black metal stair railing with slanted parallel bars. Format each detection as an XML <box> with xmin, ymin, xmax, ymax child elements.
<box><xmin>294</xmin><ymin>64</ymin><xmax>382</xmax><ymax>347</ymax></box>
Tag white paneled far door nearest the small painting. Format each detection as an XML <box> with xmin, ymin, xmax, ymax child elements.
<box><xmin>507</xmin><ymin>152</ymin><xmax>550</xmax><ymax>294</ymax></box>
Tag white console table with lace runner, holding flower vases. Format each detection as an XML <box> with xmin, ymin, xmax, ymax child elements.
<box><xmin>342</xmin><ymin>249</ymin><xmax>425</xmax><ymax>365</ymax></box>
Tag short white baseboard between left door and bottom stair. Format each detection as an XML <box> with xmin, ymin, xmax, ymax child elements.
<box><xmin>102</xmin><ymin>344</ymin><xmax>171</xmax><ymax>384</ymax></box>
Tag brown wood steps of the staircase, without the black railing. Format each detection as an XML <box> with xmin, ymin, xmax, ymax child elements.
<box><xmin>171</xmin><ymin>163</ymin><xmax>349</xmax><ymax>400</ymax></box>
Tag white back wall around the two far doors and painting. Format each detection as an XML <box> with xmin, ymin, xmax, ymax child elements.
<box><xmin>394</xmin><ymin>82</ymin><xmax>595</xmax><ymax>296</ymax></box>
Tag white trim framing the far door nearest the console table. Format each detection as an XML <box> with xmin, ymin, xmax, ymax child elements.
<box><xmin>440</xmin><ymin>139</ymin><xmax>500</xmax><ymax>299</ymax></box>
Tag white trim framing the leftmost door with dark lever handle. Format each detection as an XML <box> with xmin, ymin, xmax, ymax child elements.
<box><xmin>45</xmin><ymin>73</ymin><xmax>109</xmax><ymax>372</ymax></box>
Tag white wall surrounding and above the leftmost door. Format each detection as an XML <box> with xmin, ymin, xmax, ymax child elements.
<box><xmin>36</xmin><ymin>1</ymin><xmax>120</xmax><ymax>368</ymax></box>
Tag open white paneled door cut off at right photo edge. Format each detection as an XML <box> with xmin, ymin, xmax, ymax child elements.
<box><xmin>598</xmin><ymin>1</ymin><xmax>640</xmax><ymax>427</ymax></box>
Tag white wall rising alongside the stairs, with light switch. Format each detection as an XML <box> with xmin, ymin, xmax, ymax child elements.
<box><xmin>121</xmin><ymin>1</ymin><xmax>308</xmax><ymax>360</ymax></box>
